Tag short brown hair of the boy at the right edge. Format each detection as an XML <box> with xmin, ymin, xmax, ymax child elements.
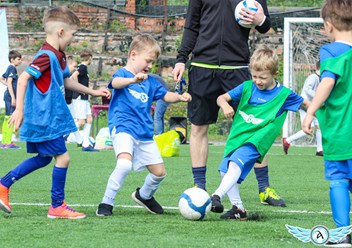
<box><xmin>321</xmin><ymin>0</ymin><xmax>352</xmax><ymax>31</ymax></box>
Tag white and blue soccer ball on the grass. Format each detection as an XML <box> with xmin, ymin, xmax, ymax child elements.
<box><xmin>178</xmin><ymin>188</ymin><xmax>211</xmax><ymax>220</ymax></box>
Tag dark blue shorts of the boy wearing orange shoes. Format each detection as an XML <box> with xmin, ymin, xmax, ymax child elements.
<box><xmin>27</xmin><ymin>137</ymin><xmax>67</xmax><ymax>157</ymax></box>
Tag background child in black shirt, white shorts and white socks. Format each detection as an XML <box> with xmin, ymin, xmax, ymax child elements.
<box><xmin>72</xmin><ymin>49</ymin><xmax>99</xmax><ymax>152</ymax></box>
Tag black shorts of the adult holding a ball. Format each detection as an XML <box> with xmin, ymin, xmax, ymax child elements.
<box><xmin>188</xmin><ymin>66</ymin><xmax>251</xmax><ymax>125</ymax></box>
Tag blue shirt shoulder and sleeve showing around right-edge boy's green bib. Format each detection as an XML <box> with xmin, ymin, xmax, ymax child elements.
<box><xmin>320</xmin><ymin>41</ymin><xmax>352</xmax><ymax>81</ymax></box>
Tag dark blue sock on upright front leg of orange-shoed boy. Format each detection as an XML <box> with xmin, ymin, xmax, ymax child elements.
<box><xmin>51</xmin><ymin>165</ymin><xmax>67</xmax><ymax>208</ymax></box>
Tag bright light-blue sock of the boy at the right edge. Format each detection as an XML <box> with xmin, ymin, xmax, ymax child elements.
<box><xmin>330</xmin><ymin>179</ymin><xmax>351</xmax><ymax>227</ymax></box>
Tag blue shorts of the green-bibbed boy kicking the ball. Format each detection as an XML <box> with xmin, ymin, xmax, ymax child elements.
<box><xmin>219</xmin><ymin>144</ymin><xmax>260</xmax><ymax>183</ymax></box>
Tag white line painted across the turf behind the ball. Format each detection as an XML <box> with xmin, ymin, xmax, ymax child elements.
<box><xmin>11</xmin><ymin>202</ymin><xmax>331</xmax><ymax>214</ymax></box>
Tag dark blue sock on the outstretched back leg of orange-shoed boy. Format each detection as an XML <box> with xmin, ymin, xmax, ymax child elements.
<box><xmin>1</xmin><ymin>155</ymin><xmax>52</xmax><ymax>188</ymax></box>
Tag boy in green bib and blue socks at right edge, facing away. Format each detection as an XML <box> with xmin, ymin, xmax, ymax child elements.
<box><xmin>303</xmin><ymin>0</ymin><xmax>352</xmax><ymax>247</ymax></box>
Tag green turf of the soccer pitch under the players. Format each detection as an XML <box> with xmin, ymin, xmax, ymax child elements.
<box><xmin>0</xmin><ymin>143</ymin><xmax>336</xmax><ymax>248</ymax></box>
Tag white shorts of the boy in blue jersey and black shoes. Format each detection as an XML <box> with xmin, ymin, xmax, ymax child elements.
<box><xmin>111</xmin><ymin>130</ymin><xmax>164</xmax><ymax>171</ymax></box>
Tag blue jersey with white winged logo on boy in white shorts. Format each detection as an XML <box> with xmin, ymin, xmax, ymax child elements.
<box><xmin>109</xmin><ymin>68</ymin><xmax>167</xmax><ymax>141</ymax></box>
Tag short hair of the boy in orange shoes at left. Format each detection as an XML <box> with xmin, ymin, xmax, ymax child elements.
<box><xmin>43</xmin><ymin>6</ymin><xmax>81</xmax><ymax>33</ymax></box>
